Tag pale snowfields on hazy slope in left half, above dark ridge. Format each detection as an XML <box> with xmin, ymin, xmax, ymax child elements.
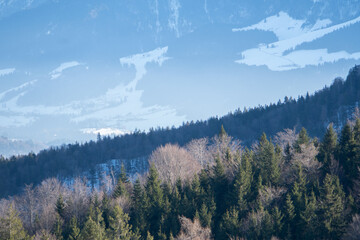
<box><xmin>0</xmin><ymin>47</ymin><xmax>185</xmax><ymax>137</ymax></box>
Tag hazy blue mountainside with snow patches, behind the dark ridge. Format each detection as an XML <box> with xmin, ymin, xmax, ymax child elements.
<box><xmin>0</xmin><ymin>0</ymin><xmax>360</xmax><ymax>148</ymax></box>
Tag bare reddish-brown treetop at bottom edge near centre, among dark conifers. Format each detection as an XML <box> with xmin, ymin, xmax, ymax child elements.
<box><xmin>176</xmin><ymin>217</ymin><xmax>212</xmax><ymax>240</ymax></box>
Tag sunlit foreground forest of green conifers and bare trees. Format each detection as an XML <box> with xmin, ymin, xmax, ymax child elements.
<box><xmin>0</xmin><ymin>121</ymin><xmax>360</xmax><ymax>240</ymax></box>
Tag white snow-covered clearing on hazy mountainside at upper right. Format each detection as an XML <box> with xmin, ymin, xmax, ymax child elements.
<box><xmin>233</xmin><ymin>12</ymin><xmax>360</xmax><ymax>71</ymax></box>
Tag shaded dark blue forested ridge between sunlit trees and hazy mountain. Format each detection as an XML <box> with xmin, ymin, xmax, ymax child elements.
<box><xmin>0</xmin><ymin>66</ymin><xmax>360</xmax><ymax>197</ymax></box>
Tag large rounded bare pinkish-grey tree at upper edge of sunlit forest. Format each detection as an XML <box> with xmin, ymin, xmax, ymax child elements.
<box><xmin>149</xmin><ymin>144</ymin><xmax>201</xmax><ymax>185</ymax></box>
